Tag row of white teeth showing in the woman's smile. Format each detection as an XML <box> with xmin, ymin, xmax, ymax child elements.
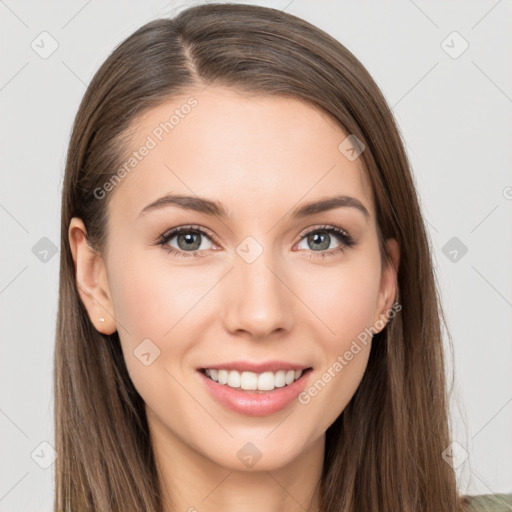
<box><xmin>205</xmin><ymin>369</ymin><xmax>302</xmax><ymax>391</ymax></box>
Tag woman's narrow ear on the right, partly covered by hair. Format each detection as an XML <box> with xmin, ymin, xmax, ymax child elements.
<box><xmin>373</xmin><ymin>238</ymin><xmax>400</xmax><ymax>333</ymax></box>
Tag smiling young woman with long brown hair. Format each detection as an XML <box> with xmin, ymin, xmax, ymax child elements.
<box><xmin>55</xmin><ymin>4</ymin><xmax>505</xmax><ymax>512</ymax></box>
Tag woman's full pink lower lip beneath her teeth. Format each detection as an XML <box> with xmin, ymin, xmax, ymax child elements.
<box><xmin>198</xmin><ymin>369</ymin><xmax>311</xmax><ymax>416</ymax></box>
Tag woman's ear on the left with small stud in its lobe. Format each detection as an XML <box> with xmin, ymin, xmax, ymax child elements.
<box><xmin>68</xmin><ymin>217</ymin><xmax>117</xmax><ymax>334</ymax></box>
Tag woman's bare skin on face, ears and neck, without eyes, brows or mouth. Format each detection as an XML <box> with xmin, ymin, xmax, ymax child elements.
<box><xmin>69</xmin><ymin>86</ymin><xmax>399</xmax><ymax>512</ymax></box>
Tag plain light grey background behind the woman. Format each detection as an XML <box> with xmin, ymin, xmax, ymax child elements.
<box><xmin>0</xmin><ymin>0</ymin><xmax>512</xmax><ymax>512</ymax></box>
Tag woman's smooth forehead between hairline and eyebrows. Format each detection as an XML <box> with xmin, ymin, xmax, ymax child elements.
<box><xmin>109</xmin><ymin>86</ymin><xmax>374</xmax><ymax>223</ymax></box>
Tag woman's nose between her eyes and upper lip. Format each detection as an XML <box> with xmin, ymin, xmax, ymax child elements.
<box><xmin>224</xmin><ymin>245</ymin><xmax>294</xmax><ymax>339</ymax></box>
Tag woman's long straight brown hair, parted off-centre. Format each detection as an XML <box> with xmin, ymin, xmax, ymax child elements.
<box><xmin>54</xmin><ymin>4</ymin><xmax>462</xmax><ymax>512</ymax></box>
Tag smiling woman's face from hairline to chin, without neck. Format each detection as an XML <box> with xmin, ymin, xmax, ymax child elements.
<box><xmin>74</xmin><ymin>86</ymin><xmax>397</xmax><ymax>470</ymax></box>
